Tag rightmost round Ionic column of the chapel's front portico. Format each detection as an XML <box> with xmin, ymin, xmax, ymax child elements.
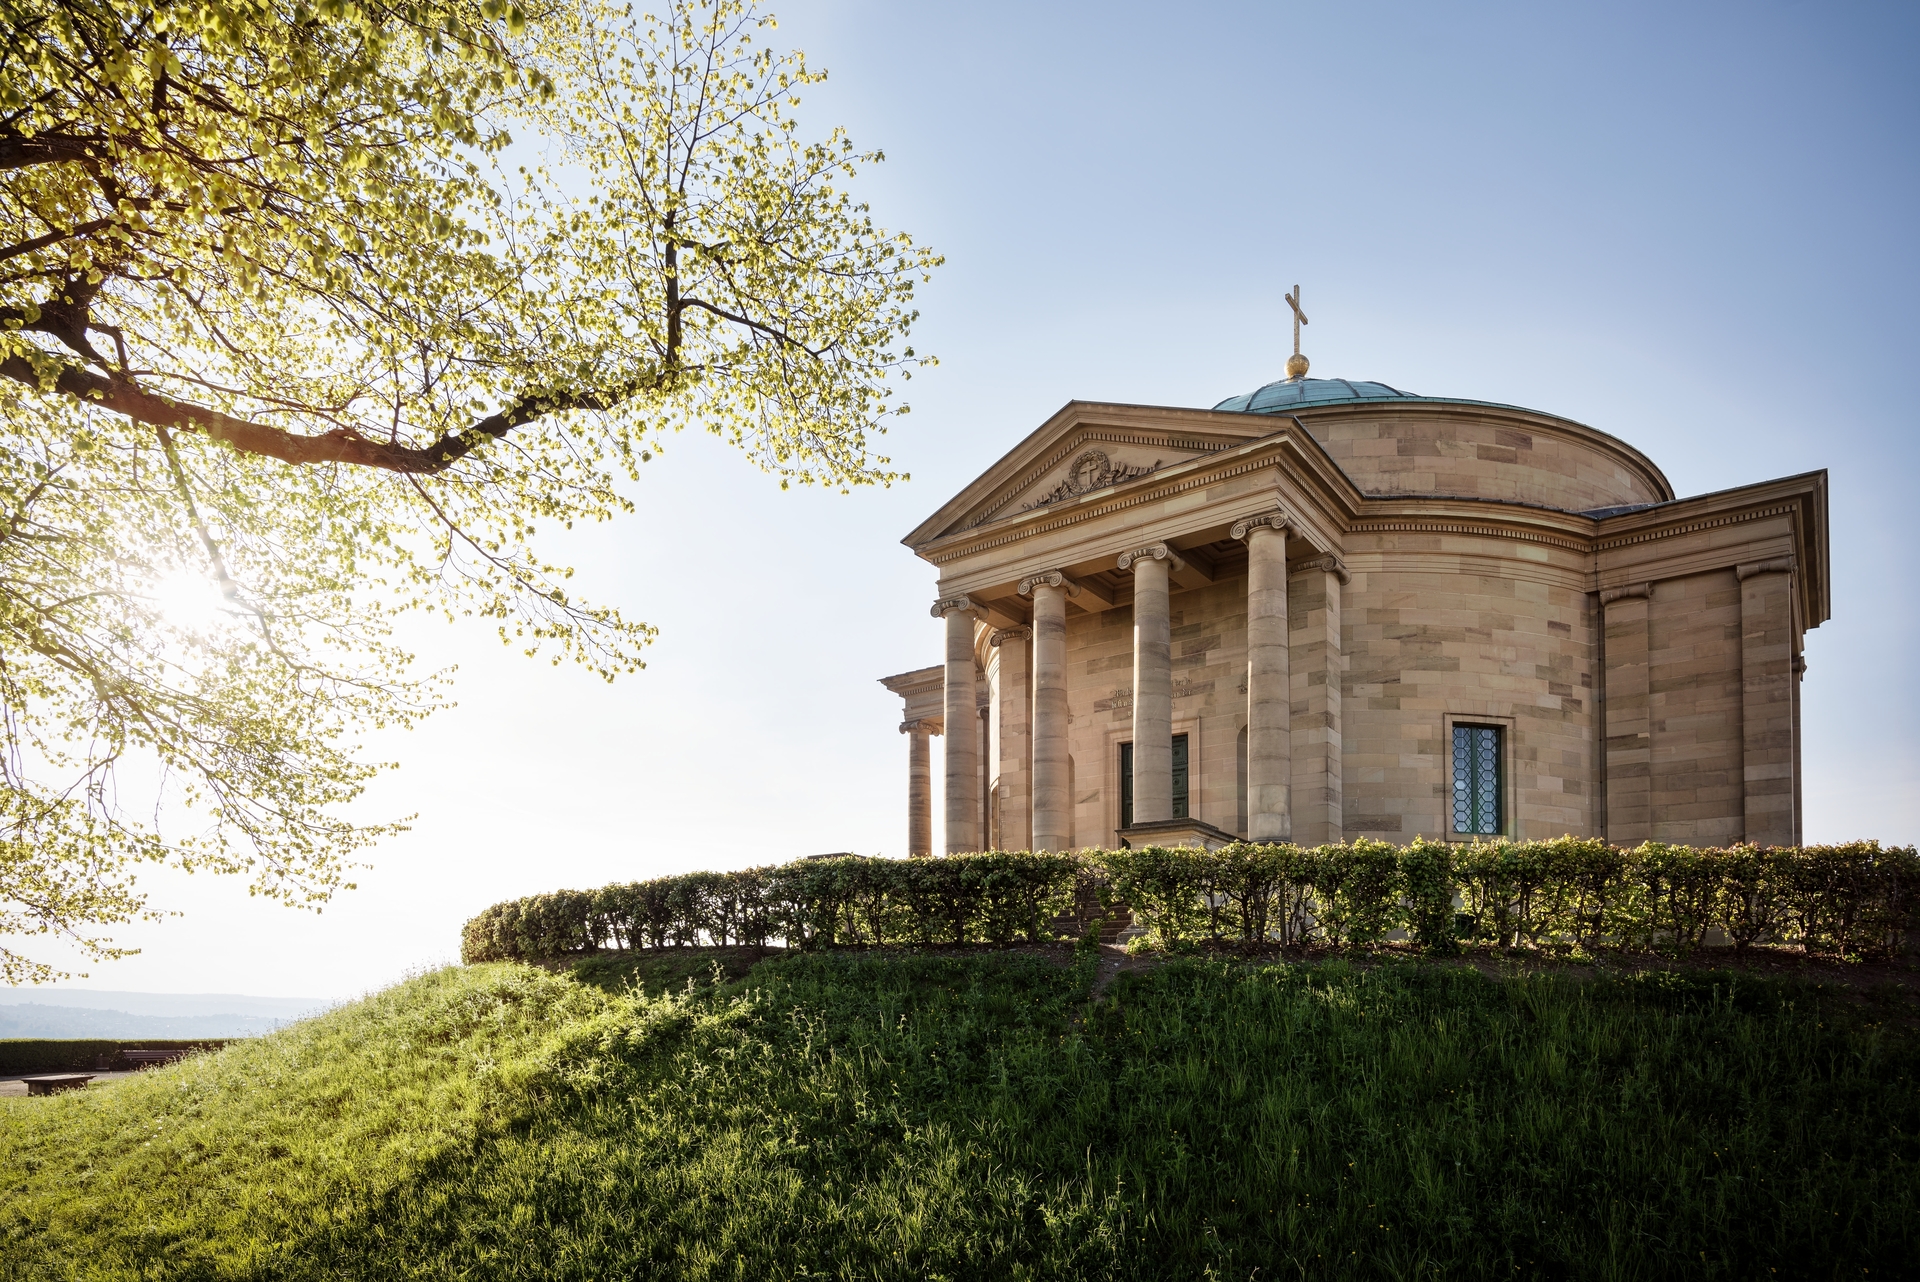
<box><xmin>1236</xmin><ymin>516</ymin><xmax>1294</xmax><ymax>841</ymax></box>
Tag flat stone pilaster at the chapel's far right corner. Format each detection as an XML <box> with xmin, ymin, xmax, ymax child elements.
<box><xmin>1734</xmin><ymin>557</ymin><xmax>1799</xmax><ymax>846</ymax></box>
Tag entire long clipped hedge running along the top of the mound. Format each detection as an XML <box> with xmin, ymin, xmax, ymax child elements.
<box><xmin>461</xmin><ymin>837</ymin><xmax>1920</xmax><ymax>962</ymax></box>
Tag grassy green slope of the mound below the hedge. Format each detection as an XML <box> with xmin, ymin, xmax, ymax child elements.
<box><xmin>0</xmin><ymin>954</ymin><xmax>1920</xmax><ymax>1280</ymax></box>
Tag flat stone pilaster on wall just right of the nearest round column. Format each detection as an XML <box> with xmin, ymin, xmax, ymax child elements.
<box><xmin>1290</xmin><ymin>557</ymin><xmax>1348</xmax><ymax>846</ymax></box>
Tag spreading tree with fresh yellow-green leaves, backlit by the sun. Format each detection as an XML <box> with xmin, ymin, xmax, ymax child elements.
<box><xmin>0</xmin><ymin>0</ymin><xmax>939</xmax><ymax>983</ymax></box>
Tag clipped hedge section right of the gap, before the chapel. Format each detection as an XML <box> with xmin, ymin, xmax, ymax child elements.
<box><xmin>1100</xmin><ymin>837</ymin><xmax>1920</xmax><ymax>956</ymax></box>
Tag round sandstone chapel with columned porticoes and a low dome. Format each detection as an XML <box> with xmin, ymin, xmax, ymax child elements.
<box><xmin>885</xmin><ymin>368</ymin><xmax>1828</xmax><ymax>854</ymax></box>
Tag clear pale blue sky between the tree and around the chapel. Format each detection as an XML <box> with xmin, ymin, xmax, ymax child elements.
<box><xmin>18</xmin><ymin>2</ymin><xmax>1920</xmax><ymax>996</ymax></box>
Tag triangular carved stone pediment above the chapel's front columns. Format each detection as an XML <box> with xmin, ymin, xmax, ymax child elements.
<box><xmin>902</xmin><ymin>401</ymin><xmax>1283</xmax><ymax>549</ymax></box>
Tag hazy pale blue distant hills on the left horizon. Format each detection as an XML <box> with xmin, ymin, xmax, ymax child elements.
<box><xmin>0</xmin><ymin>988</ymin><xmax>334</xmax><ymax>1038</ymax></box>
